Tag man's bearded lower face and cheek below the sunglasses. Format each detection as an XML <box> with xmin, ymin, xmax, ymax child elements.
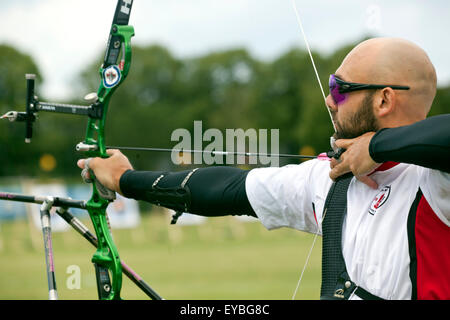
<box><xmin>330</xmin><ymin>90</ymin><xmax>379</xmax><ymax>139</ymax></box>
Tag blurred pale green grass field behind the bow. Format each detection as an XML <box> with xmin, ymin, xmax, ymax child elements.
<box><xmin>0</xmin><ymin>212</ymin><xmax>321</xmax><ymax>300</ymax></box>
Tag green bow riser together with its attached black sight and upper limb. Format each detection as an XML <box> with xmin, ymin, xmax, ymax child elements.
<box><xmin>2</xmin><ymin>0</ymin><xmax>149</xmax><ymax>300</ymax></box>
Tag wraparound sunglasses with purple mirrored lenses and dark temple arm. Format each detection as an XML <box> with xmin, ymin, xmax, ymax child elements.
<box><xmin>328</xmin><ymin>74</ymin><xmax>410</xmax><ymax>105</ymax></box>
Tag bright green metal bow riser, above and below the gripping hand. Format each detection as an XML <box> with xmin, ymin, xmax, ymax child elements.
<box><xmin>83</xmin><ymin>12</ymin><xmax>134</xmax><ymax>300</ymax></box>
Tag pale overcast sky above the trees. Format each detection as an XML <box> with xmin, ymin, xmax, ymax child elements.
<box><xmin>0</xmin><ymin>0</ymin><xmax>450</xmax><ymax>100</ymax></box>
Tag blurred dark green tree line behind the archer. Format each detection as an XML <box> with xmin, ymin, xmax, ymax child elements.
<box><xmin>0</xmin><ymin>40</ymin><xmax>450</xmax><ymax>179</ymax></box>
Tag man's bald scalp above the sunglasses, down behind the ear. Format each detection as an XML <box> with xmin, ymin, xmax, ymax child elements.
<box><xmin>336</xmin><ymin>38</ymin><xmax>437</xmax><ymax>121</ymax></box>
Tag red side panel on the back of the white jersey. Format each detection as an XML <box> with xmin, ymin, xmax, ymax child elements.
<box><xmin>415</xmin><ymin>196</ymin><xmax>450</xmax><ymax>300</ymax></box>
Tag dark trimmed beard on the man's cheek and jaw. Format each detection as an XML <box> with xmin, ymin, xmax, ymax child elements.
<box><xmin>333</xmin><ymin>92</ymin><xmax>379</xmax><ymax>139</ymax></box>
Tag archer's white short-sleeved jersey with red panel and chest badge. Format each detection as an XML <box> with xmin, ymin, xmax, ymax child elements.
<box><xmin>246</xmin><ymin>160</ymin><xmax>450</xmax><ymax>299</ymax></box>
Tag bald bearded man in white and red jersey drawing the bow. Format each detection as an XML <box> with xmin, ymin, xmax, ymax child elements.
<box><xmin>78</xmin><ymin>38</ymin><xmax>450</xmax><ymax>299</ymax></box>
